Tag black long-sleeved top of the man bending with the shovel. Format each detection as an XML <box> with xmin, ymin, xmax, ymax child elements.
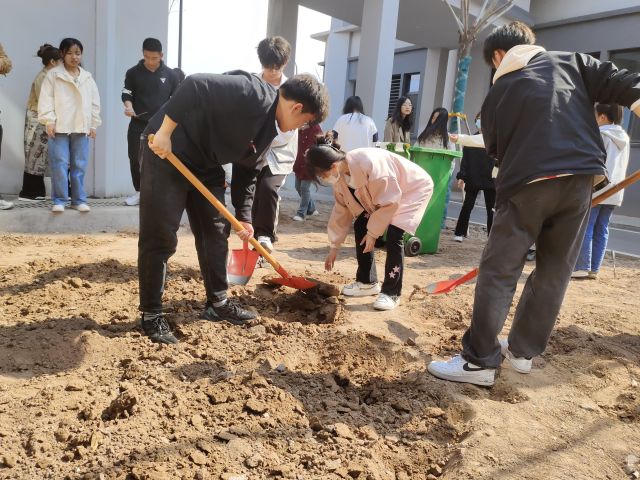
<box><xmin>145</xmin><ymin>70</ymin><xmax>278</xmax><ymax>222</ymax></box>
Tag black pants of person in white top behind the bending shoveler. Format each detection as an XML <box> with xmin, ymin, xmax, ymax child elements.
<box><xmin>251</xmin><ymin>165</ymin><xmax>287</xmax><ymax>242</ymax></box>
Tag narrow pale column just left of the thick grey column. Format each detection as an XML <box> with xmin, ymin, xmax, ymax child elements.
<box><xmin>323</xmin><ymin>18</ymin><xmax>351</xmax><ymax>130</ymax></box>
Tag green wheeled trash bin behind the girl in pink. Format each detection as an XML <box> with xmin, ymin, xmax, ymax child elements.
<box><xmin>405</xmin><ymin>147</ymin><xmax>462</xmax><ymax>256</ymax></box>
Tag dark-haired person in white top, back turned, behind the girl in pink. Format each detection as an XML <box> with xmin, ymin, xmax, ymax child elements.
<box><xmin>333</xmin><ymin>95</ymin><xmax>378</xmax><ymax>152</ymax></box>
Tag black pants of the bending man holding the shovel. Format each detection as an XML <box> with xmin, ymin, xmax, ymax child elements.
<box><xmin>138</xmin><ymin>142</ymin><xmax>231</xmax><ymax>313</ymax></box>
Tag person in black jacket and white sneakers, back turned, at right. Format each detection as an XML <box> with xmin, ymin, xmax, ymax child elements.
<box><xmin>428</xmin><ymin>22</ymin><xmax>640</xmax><ymax>386</ymax></box>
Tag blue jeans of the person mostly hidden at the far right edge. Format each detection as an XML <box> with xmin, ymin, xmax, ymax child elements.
<box><xmin>575</xmin><ymin>205</ymin><xmax>615</xmax><ymax>272</ymax></box>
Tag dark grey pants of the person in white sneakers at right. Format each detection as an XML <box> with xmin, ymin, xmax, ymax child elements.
<box><xmin>462</xmin><ymin>175</ymin><xmax>593</xmax><ymax>368</ymax></box>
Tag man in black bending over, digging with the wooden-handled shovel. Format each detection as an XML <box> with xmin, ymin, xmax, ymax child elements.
<box><xmin>138</xmin><ymin>71</ymin><xmax>328</xmax><ymax>343</ymax></box>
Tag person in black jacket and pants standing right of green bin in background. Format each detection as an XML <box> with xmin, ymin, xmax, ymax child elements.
<box><xmin>453</xmin><ymin>113</ymin><xmax>496</xmax><ymax>242</ymax></box>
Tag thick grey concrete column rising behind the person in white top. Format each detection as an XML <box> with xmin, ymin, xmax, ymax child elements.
<box><xmin>356</xmin><ymin>0</ymin><xmax>400</xmax><ymax>132</ymax></box>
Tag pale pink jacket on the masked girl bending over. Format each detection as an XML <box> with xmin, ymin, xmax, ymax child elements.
<box><xmin>327</xmin><ymin>148</ymin><xmax>433</xmax><ymax>248</ymax></box>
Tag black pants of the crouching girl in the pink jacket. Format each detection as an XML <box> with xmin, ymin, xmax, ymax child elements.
<box><xmin>353</xmin><ymin>212</ymin><xmax>404</xmax><ymax>296</ymax></box>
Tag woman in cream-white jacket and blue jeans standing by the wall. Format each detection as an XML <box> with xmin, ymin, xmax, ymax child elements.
<box><xmin>38</xmin><ymin>38</ymin><xmax>102</xmax><ymax>213</ymax></box>
